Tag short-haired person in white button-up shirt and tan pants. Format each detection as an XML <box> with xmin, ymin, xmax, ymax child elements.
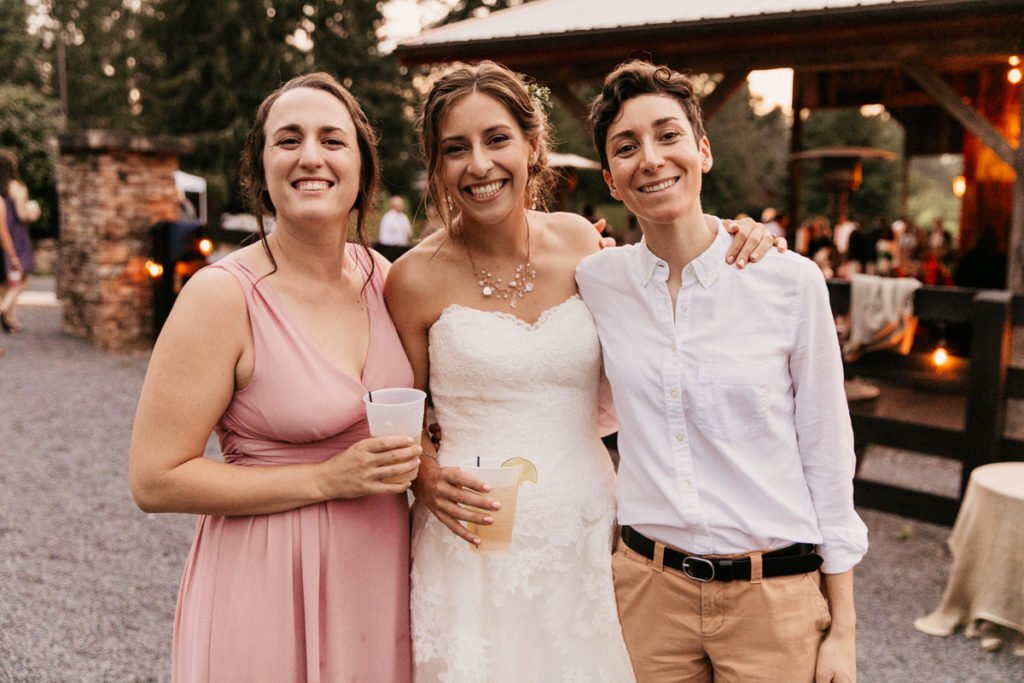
<box><xmin>577</xmin><ymin>61</ymin><xmax>867</xmax><ymax>681</ymax></box>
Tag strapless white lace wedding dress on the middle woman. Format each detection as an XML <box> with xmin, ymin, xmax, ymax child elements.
<box><xmin>412</xmin><ymin>296</ymin><xmax>634</xmax><ymax>683</ymax></box>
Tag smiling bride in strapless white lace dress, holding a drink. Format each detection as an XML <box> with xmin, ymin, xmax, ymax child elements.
<box><xmin>386</xmin><ymin>62</ymin><xmax>770</xmax><ymax>683</ymax></box>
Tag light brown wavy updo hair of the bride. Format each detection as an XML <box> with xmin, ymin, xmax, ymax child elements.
<box><xmin>420</xmin><ymin>61</ymin><xmax>555</xmax><ymax>232</ymax></box>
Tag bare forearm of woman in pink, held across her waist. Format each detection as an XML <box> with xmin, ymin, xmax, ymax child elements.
<box><xmin>130</xmin><ymin>450</ymin><xmax>328</xmax><ymax>516</ymax></box>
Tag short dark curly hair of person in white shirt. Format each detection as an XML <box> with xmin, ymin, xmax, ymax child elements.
<box><xmin>590</xmin><ymin>59</ymin><xmax>706</xmax><ymax>170</ymax></box>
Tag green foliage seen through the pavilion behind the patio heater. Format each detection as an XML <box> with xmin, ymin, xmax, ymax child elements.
<box><xmin>801</xmin><ymin>109</ymin><xmax>903</xmax><ymax>224</ymax></box>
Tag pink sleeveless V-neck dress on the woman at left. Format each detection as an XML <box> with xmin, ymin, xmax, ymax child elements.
<box><xmin>172</xmin><ymin>245</ymin><xmax>413</xmax><ymax>683</ymax></box>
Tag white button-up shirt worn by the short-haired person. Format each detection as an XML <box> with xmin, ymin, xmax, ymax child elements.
<box><xmin>577</xmin><ymin>219</ymin><xmax>867</xmax><ymax>573</ymax></box>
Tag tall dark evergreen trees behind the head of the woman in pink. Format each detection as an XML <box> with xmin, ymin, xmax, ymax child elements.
<box><xmin>142</xmin><ymin>0</ymin><xmax>415</xmax><ymax>215</ymax></box>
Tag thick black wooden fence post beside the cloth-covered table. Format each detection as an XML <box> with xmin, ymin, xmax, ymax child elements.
<box><xmin>961</xmin><ymin>290</ymin><xmax>1013</xmax><ymax>501</ymax></box>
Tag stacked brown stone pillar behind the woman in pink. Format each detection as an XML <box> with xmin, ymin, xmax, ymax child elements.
<box><xmin>56</xmin><ymin>130</ymin><xmax>190</xmax><ymax>351</ymax></box>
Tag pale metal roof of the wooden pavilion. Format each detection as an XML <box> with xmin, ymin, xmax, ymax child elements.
<box><xmin>397</xmin><ymin>0</ymin><xmax>984</xmax><ymax>52</ymax></box>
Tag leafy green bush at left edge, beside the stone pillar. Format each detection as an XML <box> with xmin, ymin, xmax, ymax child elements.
<box><xmin>0</xmin><ymin>85</ymin><xmax>60</xmax><ymax>235</ymax></box>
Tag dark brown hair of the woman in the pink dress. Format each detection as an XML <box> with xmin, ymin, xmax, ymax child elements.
<box><xmin>241</xmin><ymin>72</ymin><xmax>380</xmax><ymax>283</ymax></box>
